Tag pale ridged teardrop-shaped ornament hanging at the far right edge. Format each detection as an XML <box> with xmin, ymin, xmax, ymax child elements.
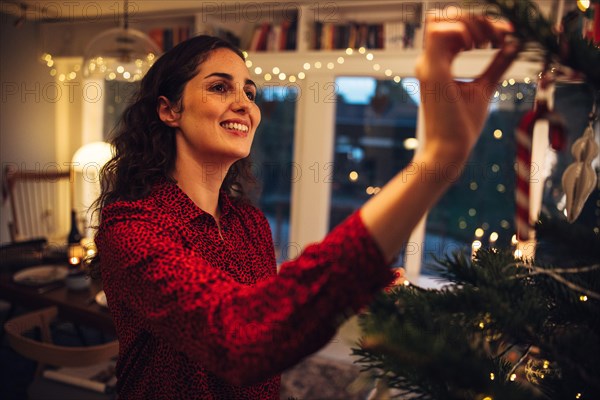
<box><xmin>562</xmin><ymin>108</ymin><xmax>598</xmax><ymax>223</ymax></box>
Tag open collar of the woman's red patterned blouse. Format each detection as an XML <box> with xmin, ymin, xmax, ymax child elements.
<box><xmin>152</xmin><ymin>179</ymin><xmax>234</xmax><ymax>223</ymax></box>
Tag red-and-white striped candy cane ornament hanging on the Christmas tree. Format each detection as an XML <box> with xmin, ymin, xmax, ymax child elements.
<box><xmin>515</xmin><ymin>66</ymin><xmax>566</xmax><ymax>241</ymax></box>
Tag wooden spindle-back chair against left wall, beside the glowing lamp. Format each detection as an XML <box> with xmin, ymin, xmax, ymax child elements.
<box><xmin>2</xmin><ymin>165</ymin><xmax>71</xmax><ymax>242</ymax></box>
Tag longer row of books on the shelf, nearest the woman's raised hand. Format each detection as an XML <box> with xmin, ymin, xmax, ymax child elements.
<box><xmin>311</xmin><ymin>22</ymin><xmax>422</xmax><ymax>50</ymax></box>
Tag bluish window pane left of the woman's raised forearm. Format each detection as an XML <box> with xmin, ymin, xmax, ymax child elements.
<box><xmin>329</xmin><ymin>77</ymin><xmax>419</xmax><ymax>264</ymax></box>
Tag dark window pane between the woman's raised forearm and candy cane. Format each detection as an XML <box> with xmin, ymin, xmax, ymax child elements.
<box><xmin>421</xmin><ymin>83</ymin><xmax>535</xmax><ymax>274</ymax></box>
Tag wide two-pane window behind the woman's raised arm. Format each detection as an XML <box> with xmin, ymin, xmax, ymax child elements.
<box><xmin>330</xmin><ymin>77</ymin><xmax>535</xmax><ymax>274</ymax></box>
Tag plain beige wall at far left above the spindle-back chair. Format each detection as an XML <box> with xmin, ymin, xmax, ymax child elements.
<box><xmin>0</xmin><ymin>14</ymin><xmax>56</xmax><ymax>243</ymax></box>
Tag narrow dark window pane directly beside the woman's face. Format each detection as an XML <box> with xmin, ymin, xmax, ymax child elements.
<box><xmin>251</xmin><ymin>86</ymin><xmax>298</xmax><ymax>262</ymax></box>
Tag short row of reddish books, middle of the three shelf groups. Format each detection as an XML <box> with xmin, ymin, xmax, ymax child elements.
<box><xmin>248</xmin><ymin>19</ymin><xmax>298</xmax><ymax>51</ymax></box>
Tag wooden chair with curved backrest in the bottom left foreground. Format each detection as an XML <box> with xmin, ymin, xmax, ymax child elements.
<box><xmin>4</xmin><ymin>307</ymin><xmax>119</xmax><ymax>400</ymax></box>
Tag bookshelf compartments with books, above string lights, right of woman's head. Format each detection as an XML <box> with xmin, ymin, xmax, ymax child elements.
<box><xmin>188</xmin><ymin>0</ymin><xmax>426</xmax><ymax>52</ymax></box>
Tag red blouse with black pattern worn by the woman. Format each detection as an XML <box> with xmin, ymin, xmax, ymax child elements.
<box><xmin>97</xmin><ymin>181</ymin><xmax>393</xmax><ymax>400</ymax></box>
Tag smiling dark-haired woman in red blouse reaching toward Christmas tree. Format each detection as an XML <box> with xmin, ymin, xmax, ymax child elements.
<box><xmin>96</xmin><ymin>12</ymin><xmax>517</xmax><ymax>400</ymax></box>
